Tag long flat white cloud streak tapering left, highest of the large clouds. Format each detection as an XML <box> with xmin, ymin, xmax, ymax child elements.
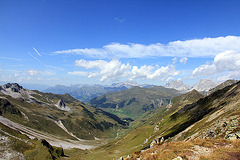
<box><xmin>54</xmin><ymin>36</ymin><xmax>240</xmax><ymax>58</ymax></box>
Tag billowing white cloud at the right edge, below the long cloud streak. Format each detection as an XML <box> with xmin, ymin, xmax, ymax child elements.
<box><xmin>192</xmin><ymin>50</ymin><xmax>240</xmax><ymax>79</ymax></box>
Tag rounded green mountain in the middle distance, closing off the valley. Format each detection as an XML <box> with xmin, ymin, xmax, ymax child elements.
<box><xmin>89</xmin><ymin>86</ymin><xmax>180</xmax><ymax>119</ymax></box>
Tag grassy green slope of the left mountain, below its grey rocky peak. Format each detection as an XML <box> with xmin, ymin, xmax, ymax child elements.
<box><xmin>0</xmin><ymin>88</ymin><xmax>127</xmax><ymax>139</ymax></box>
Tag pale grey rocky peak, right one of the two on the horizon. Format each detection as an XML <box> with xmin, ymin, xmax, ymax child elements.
<box><xmin>191</xmin><ymin>79</ymin><xmax>219</xmax><ymax>92</ymax></box>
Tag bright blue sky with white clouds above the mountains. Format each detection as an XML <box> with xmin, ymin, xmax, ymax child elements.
<box><xmin>0</xmin><ymin>0</ymin><xmax>240</xmax><ymax>86</ymax></box>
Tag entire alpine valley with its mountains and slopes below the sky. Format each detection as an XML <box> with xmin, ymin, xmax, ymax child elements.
<box><xmin>0</xmin><ymin>80</ymin><xmax>240</xmax><ymax>160</ymax></box>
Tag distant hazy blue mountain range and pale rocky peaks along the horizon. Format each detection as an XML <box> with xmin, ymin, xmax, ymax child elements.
<box><xmin>43</xmin><ymin>79</ymin><xmax>219</xmax><ymax>102</ymax></box>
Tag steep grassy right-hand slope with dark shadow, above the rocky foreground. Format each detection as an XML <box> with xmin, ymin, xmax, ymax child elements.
<box><xmin>79</xmin><ymin>84</ymin><xmax>240</xmax><ymax>159</ymax></box>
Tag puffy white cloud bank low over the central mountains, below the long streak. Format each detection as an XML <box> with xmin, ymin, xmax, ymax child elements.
<box><xmin>72</xmin><ymin>59</ymin><xmax>179</xmax><ymax>81</ymax></box>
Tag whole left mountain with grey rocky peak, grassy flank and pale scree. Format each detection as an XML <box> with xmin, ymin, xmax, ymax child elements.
<box><xmin>0</xmin><ymin>83</ymin><xmax>127</xmax><ymax>148</ymax></box>
